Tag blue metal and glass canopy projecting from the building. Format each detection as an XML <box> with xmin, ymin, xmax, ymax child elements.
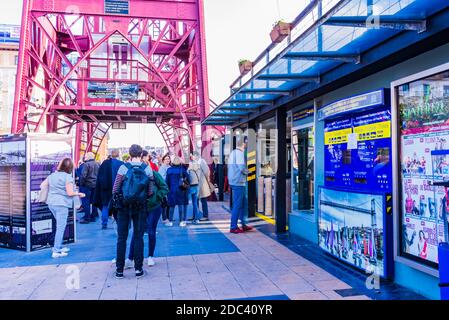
<box><xmin>202</xmin><ymin>0</ymin><xmax>449</xmax><ymax>126</ymax></box>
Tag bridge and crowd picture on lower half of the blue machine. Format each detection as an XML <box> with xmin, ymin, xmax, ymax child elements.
<box><xmin>318</xmin><ymin>188</ymin><xmax>386</xmax><ymax>277</ymax></box>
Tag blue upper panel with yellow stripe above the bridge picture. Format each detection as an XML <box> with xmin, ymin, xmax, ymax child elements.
<box><xmin>324</xmin><ymin>107</ymin><xmax>392</xmax><ymax>192</ymax></box>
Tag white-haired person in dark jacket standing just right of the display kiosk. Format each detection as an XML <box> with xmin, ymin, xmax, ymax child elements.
<box><xmin>80</xmin><ymin>152</ymin><xmax>100</xmax><ymax>224</ymax></box>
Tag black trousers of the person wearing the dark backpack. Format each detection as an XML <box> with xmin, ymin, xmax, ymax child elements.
<box><xmin>116</xmin><ymin>209</ymin><xmax>147</xmax><ymax>272</ymax></box>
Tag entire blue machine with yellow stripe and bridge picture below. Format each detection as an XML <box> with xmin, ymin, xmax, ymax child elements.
<box><xmin>318</xmin><ymin>89</ymin><xmax>393</xmax><ymax>278</ymax></box>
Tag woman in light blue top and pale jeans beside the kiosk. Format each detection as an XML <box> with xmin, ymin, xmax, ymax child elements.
<box><xmin>41</xmin><ymin>158</ymin><xmax>85</xmax><ymax>258</ymax></box>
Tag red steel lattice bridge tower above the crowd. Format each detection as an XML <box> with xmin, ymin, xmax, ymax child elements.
<box><xmin>12</xmin><ymin>0</ymin><xmax>222</xmax><ymax>161</ymax></box>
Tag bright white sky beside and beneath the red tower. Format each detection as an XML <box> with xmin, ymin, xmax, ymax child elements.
<box><xmin>0</xmin><ymin>0</ymin><xmax>304</xmax><ymax>147</ymax></box>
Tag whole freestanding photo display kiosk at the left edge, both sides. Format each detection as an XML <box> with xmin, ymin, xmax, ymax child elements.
<box><xmin>0</xmin><ymin>134</ymin><xmax>75</xmax><ymax>251</ymax></box>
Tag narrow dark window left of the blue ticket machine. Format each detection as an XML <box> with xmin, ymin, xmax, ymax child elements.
<box><xmin>292</xmin><ymin>127</ymin><xmax>315</xmax><ymax>212</ymax></box>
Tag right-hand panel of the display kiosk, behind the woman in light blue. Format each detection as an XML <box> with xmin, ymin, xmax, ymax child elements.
<box><xmin>30</xmin><ymin>136</ymin><xmax>75</xmax><ymax>250</ymax></box>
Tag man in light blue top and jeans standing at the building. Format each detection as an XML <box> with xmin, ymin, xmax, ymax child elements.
<box><xmin>228</xmin><ymin>138</ymin><xmax>253</xmax><ymax>233</ymax></box>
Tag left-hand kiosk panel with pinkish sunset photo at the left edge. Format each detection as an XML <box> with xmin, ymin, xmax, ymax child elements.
<box><xmin>0</xmin><ymin>136</ymin><xmax>26</xmax><ymax>250</ymax></box>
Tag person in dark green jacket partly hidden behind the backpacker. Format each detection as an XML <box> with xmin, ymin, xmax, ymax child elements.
<box><xmin>125</xmin><ymin>171</ymin><xmax>168</xmax><ymax>268</ymax></box>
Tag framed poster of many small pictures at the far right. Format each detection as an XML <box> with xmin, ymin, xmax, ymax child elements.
<box><xmin>397</xmin><ymin>72</ymin><xmax>449</xmax><ymax>267</ymax></box>
